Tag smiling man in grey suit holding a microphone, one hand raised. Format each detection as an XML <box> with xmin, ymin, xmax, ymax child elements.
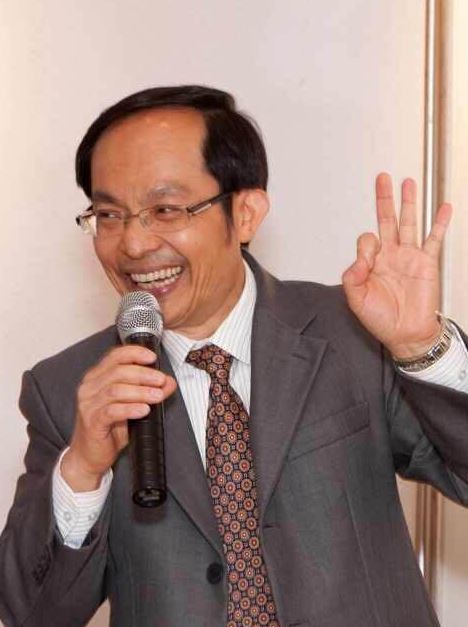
<box><xmin>0</xmin><ymin>86</ymin><xmax>468</xmax><ymax>627</ymax></box>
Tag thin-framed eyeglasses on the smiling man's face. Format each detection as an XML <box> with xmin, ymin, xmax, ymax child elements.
<box><xmin>75</xmin><ymin>192</ymin><xmax>232</xmax><ymax>239</ymax></box>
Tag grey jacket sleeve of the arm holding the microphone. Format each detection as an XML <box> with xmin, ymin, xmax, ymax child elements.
<box><xmin>0</xmin><ymin>372</ymin><xmax>111</xmax><ymax>627</ymax></box>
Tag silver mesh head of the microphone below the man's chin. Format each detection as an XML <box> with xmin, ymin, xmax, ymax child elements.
<box><xmin>116</xmin><ymin>291</ymin><xmax>163</xmax><ymax>344</ymax></box>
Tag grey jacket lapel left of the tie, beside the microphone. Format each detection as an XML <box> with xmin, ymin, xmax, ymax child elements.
<box><xmin>161</xmin><ymin>352</ymin><xmax>223</xmax><ymax>555</ymax></box>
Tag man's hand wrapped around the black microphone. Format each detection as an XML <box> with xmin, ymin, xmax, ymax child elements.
<box><xmin>61</xmin><ymin>292</ymin><xmax>177</xmax><ymax>506</ymax></box>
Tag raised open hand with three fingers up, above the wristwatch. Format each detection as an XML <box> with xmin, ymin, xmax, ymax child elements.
<box><xmin>343</xmin><ymin>173</ymin><xmax>452</xmax><ymax>359</ymax></box>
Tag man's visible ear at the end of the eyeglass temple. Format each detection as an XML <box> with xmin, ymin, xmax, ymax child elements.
<box><xmin>232</xmin><ymin>189</ymin><xmax>270</xmax><ymax>244</ymax></box>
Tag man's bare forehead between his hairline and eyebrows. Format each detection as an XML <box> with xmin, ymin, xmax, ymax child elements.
<box><xmin>91</xmin><ymin>107</ymin><xmax>209</xmax><ymax>196</ymax></box>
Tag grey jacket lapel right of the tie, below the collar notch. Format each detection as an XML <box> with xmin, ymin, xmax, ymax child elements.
<box><xmin>250</xmin><ymin>306</ymin><xmax>327</xmax><ymax>517</ymax></box>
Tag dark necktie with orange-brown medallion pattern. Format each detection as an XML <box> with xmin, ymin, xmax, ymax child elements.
<box><xmin>187</xmin><ymin>344</ymin><xmax>279</xmax><ymax>627</ymax></box>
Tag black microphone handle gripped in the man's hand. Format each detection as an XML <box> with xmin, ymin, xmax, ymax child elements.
<box><xmin>125</xmin><ymin>333</ymin><xmax>167</xmax><ymax>507</ymax></box>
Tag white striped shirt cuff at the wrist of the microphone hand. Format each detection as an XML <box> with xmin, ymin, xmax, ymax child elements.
<box><xmin>52</xmin><ymin>448</ymin><xmax>112</xmax><ymax>549</ymax></box>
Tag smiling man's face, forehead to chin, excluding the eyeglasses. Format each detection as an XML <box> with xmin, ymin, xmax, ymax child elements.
<box><xmin>91</xmin><ymin>109</ymin><xmax>264</xmax><ymax>338</ymax></box>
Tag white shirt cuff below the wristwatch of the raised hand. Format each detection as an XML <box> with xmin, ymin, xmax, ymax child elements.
<box><xmin>398</xmin><ymin>320</ymin><xmax>468</xmax><ymax>393</ymax></box>
